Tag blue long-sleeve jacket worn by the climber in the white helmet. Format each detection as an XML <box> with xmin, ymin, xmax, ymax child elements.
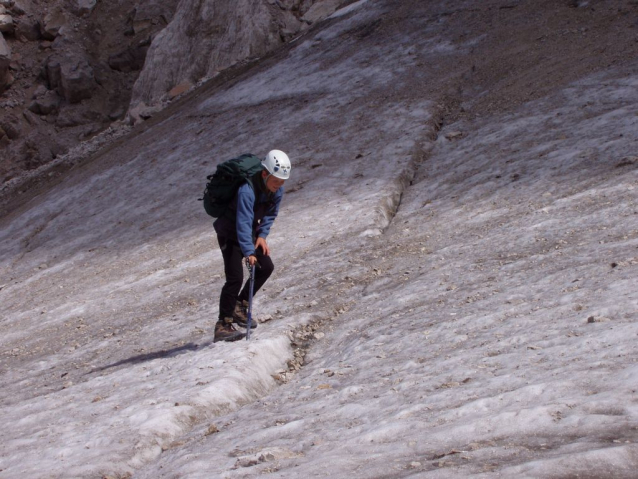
<box><xmin>214</xmin><ymin>176</ymin><xmax>284</xmax><ymax>257</ymax></box>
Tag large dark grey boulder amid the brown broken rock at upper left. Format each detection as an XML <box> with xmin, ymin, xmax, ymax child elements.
<box><xmin>45</xmin><ymin>54</ymin><xmax>97</xmax><ymax>103</ymax></box>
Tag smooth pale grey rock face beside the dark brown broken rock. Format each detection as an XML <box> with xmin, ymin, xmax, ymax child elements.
<box><xmin>131</xmin><ymin>0</ymin><xmax>349</xmax><ymax>106</ymax></box>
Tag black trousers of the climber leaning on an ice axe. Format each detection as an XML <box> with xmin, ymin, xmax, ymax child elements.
<box><xmin>217</xmin><ymin>236</ymin><xmax>275</xmax><ymax>321</ymax></box>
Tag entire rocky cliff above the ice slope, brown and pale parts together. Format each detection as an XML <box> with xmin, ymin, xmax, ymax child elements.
<box><xmin>0</xmin><ymin>0</ymin><xmax>351</xmax><ymax>185</ymax></box>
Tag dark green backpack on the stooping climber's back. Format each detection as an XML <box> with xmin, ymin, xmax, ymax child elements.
<box><xmin>201</xmin><ymin>153</ymin><xmax>263</xmax><ymax>218</ymax></box>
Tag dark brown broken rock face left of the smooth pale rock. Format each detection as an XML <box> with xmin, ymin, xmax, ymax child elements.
<box><xmin>0</xmin><ymin>0</ymin><xmax>178</xmax><ymax>184</ymax></box>
